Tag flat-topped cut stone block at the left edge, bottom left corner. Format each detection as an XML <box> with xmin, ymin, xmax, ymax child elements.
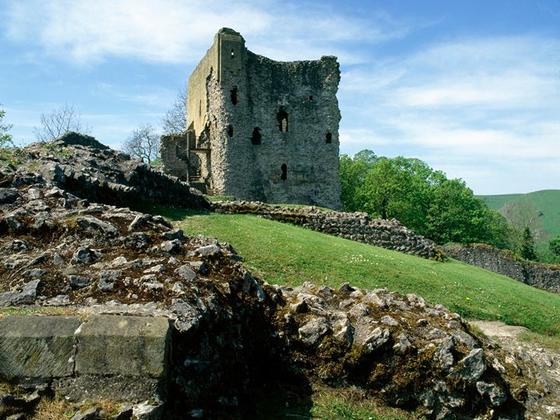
<box><xmin>0</xmin><ymin>316</ymin><xmax>81</xmax><ymax>380</ymax></box>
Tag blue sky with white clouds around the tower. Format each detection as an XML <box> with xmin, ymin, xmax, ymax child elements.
<box><xmin>0</xmin><ymin>0</ymin><xmax>560</xmax><ymax>194</ymax></box>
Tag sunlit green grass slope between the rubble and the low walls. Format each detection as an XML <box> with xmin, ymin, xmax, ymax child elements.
<box><xmin>164</xmin><ymin>210</ymin><xmax>560</xmax><ymax>337</ymax></box>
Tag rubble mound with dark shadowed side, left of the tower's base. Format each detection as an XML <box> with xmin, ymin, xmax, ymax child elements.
<box><xmin>0</xmin><ymin>133</ymin><xmax>209</xmax><ymax>209</ymax></box>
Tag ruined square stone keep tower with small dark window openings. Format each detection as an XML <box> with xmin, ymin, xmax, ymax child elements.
<box><xmin>162</xmin><ymin>28</ymin><xmax>340</xmax><ymax>208</ymax></box>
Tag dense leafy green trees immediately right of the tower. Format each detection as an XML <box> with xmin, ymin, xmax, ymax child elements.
<box><xmin>340</xmin><ymin>150</ymin><xmax>512</xmax><ymax>248</ymax></box>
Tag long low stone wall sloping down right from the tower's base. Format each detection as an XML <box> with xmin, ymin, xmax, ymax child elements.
<box><xmin>212</xmin><ymin>201</ymin><xmax>444</xmax><ymax>260</ymax></box>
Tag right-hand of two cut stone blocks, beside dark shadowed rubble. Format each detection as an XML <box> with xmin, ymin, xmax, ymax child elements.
<box><xmin>75</xmin><ymin>315</ymin><xmax>170</xmax><ymax>378</ymax></box>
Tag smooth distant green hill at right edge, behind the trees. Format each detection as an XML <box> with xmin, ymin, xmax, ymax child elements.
<box><xmin>480</xmin><ymin>190</ymin><xmax>560</xmax><ymax>260</ymax></box>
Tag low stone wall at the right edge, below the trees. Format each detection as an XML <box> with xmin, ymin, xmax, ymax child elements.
<box><xmin>444</xmin><ymin>244</ymin><xmax>560</xmax><ymax>293</ymax></box>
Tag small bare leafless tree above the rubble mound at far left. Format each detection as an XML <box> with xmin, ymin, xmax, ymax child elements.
<box><xmin>35</xmin><ymin>104</ymin><xmax>88</xmax><ymax>142</ymax></box>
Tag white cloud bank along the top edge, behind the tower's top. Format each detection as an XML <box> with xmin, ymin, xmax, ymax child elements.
<box><xmin>3</xmin><ymin>0</ymin><xmax>408</xmax><ymax>63</ymax></box>
